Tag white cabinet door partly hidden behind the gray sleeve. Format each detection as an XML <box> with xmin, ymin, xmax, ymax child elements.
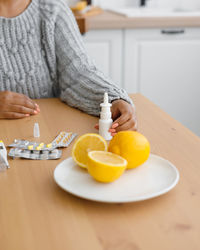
<box><xmin>84</xmin><ymin>30</ymin><xmax>122</xmax><ymax>86</ymax></box>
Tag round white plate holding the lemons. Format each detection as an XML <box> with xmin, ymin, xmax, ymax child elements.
<box><xmin>54</xmin><ymin>154</ymin><xmax>179</xmax><ymax>203</ymax></box>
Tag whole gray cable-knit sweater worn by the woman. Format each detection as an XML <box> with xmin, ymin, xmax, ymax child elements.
<box><xmin>0</xmin><ymin>0</ymin><xmax>131</xmax><ymax>115</ymax></box>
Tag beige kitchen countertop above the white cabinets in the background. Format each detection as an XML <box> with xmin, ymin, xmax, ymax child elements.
<box><xmin>86</xmin><ymin>11</ymin><xmax>200</xmax><ymax>31</ymax></box>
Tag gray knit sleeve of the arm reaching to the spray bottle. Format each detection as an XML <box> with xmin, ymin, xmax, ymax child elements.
<box><xmin>55</xmin><ymin>0</ymin><xmax>132</xmax><ymax>116</ymax></box>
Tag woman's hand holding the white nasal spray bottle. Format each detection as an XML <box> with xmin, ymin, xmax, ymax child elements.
<box><xmin>95</xmin><ymin>100</ymin><xmax>137</xmax><ymax>136</ymax></box>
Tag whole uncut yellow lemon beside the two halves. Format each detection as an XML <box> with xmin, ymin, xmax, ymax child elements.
<box><xmin>108</xmin><ymin>131</ymin><xmax>150</xmax><ymax>168</ymax></box>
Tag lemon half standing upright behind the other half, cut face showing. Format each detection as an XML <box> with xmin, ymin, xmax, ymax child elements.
<box><xmin>72</xmin><ymin>133</ymin><xmax>108</xmax><ymax>168</ymax></box>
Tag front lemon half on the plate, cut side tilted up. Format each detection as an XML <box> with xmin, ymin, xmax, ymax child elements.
<box><xmin>87</xmin><ymin>151</ymin><xmax>127</xmax><ymax>182</ymax></box>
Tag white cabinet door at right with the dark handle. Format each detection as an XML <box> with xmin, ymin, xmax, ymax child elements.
<box><xmin>125</xmin><ymin>29</ymin><xmax>200</xmax><ymax>136</ymax></box>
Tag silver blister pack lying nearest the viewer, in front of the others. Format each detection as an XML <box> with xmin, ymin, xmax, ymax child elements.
<box><xmin>8</xmin><ymin>148</ymin><xmax>62</xmax><ymax>160</ymax></box>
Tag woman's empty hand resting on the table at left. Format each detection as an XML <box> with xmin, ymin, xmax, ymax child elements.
<box><xmin>0</xmin><ymin>91</ymin><xmax>40</xmax><ymax>119</ymax></box>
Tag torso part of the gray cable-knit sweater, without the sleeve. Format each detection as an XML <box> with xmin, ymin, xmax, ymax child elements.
<box><xmin>0</xmin><ymin>0</ymin><xmax>59</xmax><ymax>98</ymax></box>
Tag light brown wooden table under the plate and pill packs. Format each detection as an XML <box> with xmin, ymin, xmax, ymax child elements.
<box><xmin>0</xmin><ymin>94</ymin><xmax>200</xmax><ymax>250</ymax></box>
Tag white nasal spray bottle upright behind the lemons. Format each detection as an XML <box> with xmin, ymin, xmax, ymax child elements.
<box><xmin>99</xmin><ymin>93</ymin><xmax>113</xmax><ymax>141</ymax></box>
